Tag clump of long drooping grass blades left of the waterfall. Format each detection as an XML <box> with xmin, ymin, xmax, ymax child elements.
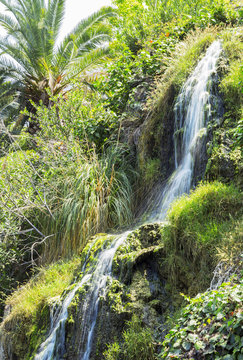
<box><xmin>37</xmin><ymin>142</ymin><xmax>134</xmax><ymax>261</ymax></box>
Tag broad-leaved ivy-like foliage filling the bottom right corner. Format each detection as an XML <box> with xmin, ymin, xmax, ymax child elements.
<box><xmin>159</xmin><ymin>281</ymin><xmax>243</xmax><ymax>360</ymax></box>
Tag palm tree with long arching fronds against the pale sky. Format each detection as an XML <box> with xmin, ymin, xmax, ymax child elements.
<box><xmin>0</xmin><ymin>0</ymin><xmax>114</xmax><ymax>129</ymax></box>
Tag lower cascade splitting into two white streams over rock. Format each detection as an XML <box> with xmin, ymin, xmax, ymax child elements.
<box><xmin>34</xmin><ymin>231</ymin><xmax>131</xmax><ymax>360</ymax></box>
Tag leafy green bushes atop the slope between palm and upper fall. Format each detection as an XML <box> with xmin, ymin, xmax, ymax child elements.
<box><xmin>94</xmin><ymin>0</ymin><xmax>240</xmax><ymax>113</ymax></box>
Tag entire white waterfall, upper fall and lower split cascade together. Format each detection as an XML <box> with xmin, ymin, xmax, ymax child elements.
<box><xmin>0</xmin><ymin>41</ymin><xmax>221</xmax><ymax>360</ymax></box>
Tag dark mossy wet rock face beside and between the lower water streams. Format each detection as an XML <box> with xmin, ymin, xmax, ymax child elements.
<box><xmin>65</xmin><ymin>224</ymin><xmax>171</xmax><ymax>360</ymax></box>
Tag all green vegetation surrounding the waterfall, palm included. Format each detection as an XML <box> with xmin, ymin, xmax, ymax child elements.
<box><xmin>0</xmin><ymin>0</ymin><xmax>243</xmax><ymax>360</ymax></box>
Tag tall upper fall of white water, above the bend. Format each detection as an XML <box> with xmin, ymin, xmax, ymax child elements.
<box><xmin>150</xmin><ymin>41</ymin><xmax>222</xmax><ymax>221</ymax></box>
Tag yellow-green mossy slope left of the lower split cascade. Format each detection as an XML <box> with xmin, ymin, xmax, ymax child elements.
<box><xmin>0</xmin><ymin>257</ymin><xmax>80</xmax><ymax>360</ymax></box>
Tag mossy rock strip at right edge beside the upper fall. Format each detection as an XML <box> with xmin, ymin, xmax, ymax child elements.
<box><xmin>206</xmin><ymin>28</ymin><xmax>243</xmax><ymax>188</ymax></box>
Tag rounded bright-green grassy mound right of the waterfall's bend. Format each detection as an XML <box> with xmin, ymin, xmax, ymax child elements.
<box><xmin>163</xmin><ymin>182</ymin><xmax>243</xmax><ymax>295</ymax></box>
